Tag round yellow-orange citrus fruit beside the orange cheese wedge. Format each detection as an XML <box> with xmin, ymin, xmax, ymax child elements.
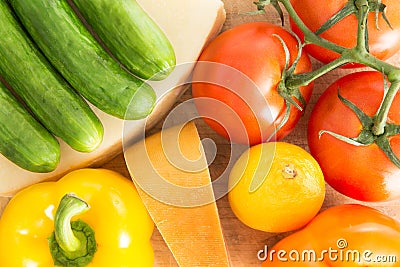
<box><xmin>228</xmin><ymin>142</ymin><xmax>325</xmax><ymax>232</ymax></box>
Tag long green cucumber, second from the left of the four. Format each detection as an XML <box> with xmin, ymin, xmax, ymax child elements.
<box><xmin>0</xmin><ymin>0</ymin><xmax>103</xmax><ymax>152</ymax></box>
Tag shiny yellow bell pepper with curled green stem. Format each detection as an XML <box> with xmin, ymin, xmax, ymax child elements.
<box><xmin>0</xmin><ymin>169</ymin><xmax>154</xmax><ymax>267</ymax></box>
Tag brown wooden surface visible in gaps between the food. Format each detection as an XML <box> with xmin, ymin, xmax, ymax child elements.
<box><xmin>0</xmin><ymin>0</ymin><xmax>400</xmax><ymax>267</ymax></box>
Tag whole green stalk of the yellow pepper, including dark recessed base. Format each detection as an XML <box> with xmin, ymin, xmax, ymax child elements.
<box><xmin>49</xmin><ymin>194</ymin><xmax>96</xmax><ymax>267</ymax></box>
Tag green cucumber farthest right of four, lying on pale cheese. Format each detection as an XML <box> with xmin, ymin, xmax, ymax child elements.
<box><xmin>73</xmin><ymin>0</ymin><xmax>176</xmax><ymax>80</ymax></box>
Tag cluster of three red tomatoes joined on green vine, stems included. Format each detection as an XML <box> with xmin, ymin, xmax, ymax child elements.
<box><xmin>192</xmin><ymin>0</ymin><xmax>400</xmax><ymax>201</ymax></box>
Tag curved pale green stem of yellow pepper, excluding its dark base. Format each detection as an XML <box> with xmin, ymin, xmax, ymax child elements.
<box><xmin>54</xmin><ymin>194</ymin><xmax>90</xmax><ymax>252</ymax></box>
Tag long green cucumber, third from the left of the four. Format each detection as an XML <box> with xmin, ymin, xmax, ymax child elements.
<box><xmin>9</xmin><ymin>0</ymin><xmax>156</xmax><ymax>119</ymax></box>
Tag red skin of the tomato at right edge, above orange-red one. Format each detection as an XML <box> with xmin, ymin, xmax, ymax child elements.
<box><xmin>308</xmin><ymin>71</ymin><xmax>400</xmax><ymax>201</ymax></box>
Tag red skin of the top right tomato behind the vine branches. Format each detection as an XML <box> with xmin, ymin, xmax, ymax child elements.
<box><xmin>291</xmin><ymin>0</ymin><xmax>400</xmax><ymax>66</ymax></box>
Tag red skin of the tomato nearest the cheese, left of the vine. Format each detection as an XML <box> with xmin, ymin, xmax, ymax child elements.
<box><xmin>192</xmin><ymin>22</ymin><xmax>313</xmax><ymax>145</ymax></box>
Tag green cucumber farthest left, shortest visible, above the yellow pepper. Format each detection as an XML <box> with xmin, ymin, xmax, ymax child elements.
<box><xmin>0</xmin><ymin>81</ymin><xmax>60</xmax><ymax>172</ymax></box>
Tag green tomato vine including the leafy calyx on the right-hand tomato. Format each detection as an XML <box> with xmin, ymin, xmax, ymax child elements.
<box><xmin>254</xmin><ymin>0</ymin><xmax>400</xmax><ymax>168</ymax></box>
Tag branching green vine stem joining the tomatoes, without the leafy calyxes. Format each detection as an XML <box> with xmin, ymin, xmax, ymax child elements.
<box><xmin>256</xmin><ymin>0</ymin><xmax>400</xmax><ymax>136</ymax></box>
